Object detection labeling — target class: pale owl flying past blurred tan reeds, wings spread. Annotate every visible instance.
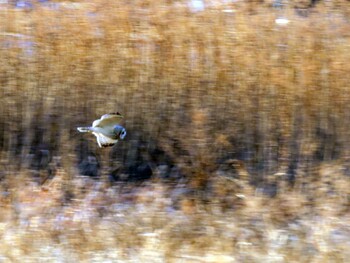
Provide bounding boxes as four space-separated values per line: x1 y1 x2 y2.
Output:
77 112 126 148
